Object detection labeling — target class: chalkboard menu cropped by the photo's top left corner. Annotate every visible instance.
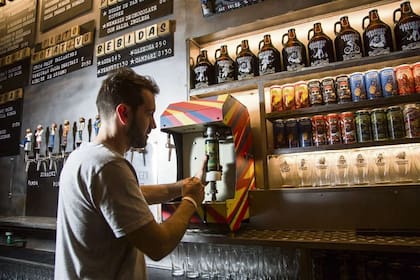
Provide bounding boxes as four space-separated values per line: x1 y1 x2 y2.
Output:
0 0 37 57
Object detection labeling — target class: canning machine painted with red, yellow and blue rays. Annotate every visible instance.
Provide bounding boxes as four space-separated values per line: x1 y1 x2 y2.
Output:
160 95 255 231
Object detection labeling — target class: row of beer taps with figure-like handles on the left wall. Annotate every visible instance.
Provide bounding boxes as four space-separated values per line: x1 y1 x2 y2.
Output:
21 115 101 172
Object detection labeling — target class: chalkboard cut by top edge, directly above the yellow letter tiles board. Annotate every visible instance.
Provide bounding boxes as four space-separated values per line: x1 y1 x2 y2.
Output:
40 0 93 32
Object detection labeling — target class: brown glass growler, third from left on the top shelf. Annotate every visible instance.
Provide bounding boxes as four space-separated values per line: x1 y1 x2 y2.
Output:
236 40 258 80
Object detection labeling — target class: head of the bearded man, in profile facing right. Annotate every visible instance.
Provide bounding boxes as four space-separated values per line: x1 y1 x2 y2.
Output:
96 68 159 148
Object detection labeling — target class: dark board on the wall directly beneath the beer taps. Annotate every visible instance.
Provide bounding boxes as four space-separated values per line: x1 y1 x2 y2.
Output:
26 159 63 217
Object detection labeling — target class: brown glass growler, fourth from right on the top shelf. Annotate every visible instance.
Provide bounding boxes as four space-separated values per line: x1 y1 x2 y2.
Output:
308 22 334 66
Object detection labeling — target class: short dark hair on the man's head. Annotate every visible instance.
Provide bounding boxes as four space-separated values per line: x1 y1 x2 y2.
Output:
96 67 159 118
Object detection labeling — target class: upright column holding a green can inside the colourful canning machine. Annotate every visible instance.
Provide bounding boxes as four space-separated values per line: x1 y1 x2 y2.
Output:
204 126 222 201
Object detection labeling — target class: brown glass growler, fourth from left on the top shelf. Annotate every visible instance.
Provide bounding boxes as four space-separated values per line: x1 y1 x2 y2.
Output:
258 34 281 76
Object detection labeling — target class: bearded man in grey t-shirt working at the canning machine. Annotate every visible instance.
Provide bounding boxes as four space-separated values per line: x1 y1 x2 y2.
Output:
55 68 205 280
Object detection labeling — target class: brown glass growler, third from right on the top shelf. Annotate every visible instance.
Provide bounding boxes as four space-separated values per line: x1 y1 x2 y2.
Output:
334 16 363 61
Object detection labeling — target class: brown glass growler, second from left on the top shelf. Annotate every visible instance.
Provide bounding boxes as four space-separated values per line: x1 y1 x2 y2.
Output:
214 45 236 84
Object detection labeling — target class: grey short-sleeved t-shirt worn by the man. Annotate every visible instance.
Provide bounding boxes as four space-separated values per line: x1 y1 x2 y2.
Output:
55 143 154 280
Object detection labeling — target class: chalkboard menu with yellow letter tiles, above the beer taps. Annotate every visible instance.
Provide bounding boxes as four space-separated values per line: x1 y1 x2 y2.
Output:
31 21 95 85
